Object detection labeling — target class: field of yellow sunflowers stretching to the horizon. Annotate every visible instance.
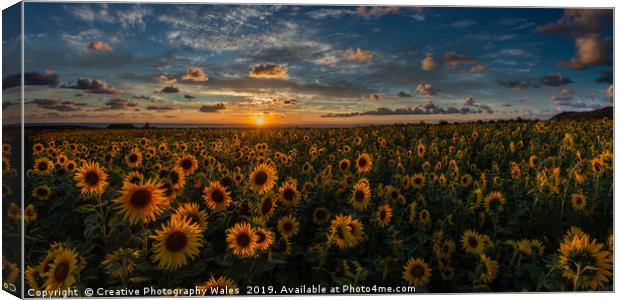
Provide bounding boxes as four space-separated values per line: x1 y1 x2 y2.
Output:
3 119 613 294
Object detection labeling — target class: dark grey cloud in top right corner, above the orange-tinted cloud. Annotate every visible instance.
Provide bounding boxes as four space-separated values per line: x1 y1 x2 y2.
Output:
536 9 613 37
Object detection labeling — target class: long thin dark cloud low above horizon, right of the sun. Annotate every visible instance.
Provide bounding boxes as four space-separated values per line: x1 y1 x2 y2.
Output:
321 103 492 118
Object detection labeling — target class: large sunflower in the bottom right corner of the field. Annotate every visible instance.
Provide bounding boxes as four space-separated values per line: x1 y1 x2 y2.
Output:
558 234 613 290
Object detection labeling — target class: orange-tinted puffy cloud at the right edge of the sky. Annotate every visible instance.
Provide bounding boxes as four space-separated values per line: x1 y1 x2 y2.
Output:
558 35 613 70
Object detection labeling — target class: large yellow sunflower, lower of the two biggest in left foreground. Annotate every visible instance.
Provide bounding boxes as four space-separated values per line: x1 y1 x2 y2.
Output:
151 216 202 271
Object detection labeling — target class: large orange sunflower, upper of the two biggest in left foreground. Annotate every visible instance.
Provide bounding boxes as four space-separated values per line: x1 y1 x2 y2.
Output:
112 179 168 225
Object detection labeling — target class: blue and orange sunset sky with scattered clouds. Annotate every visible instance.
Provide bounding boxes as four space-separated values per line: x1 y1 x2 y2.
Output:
3 3 613 126
